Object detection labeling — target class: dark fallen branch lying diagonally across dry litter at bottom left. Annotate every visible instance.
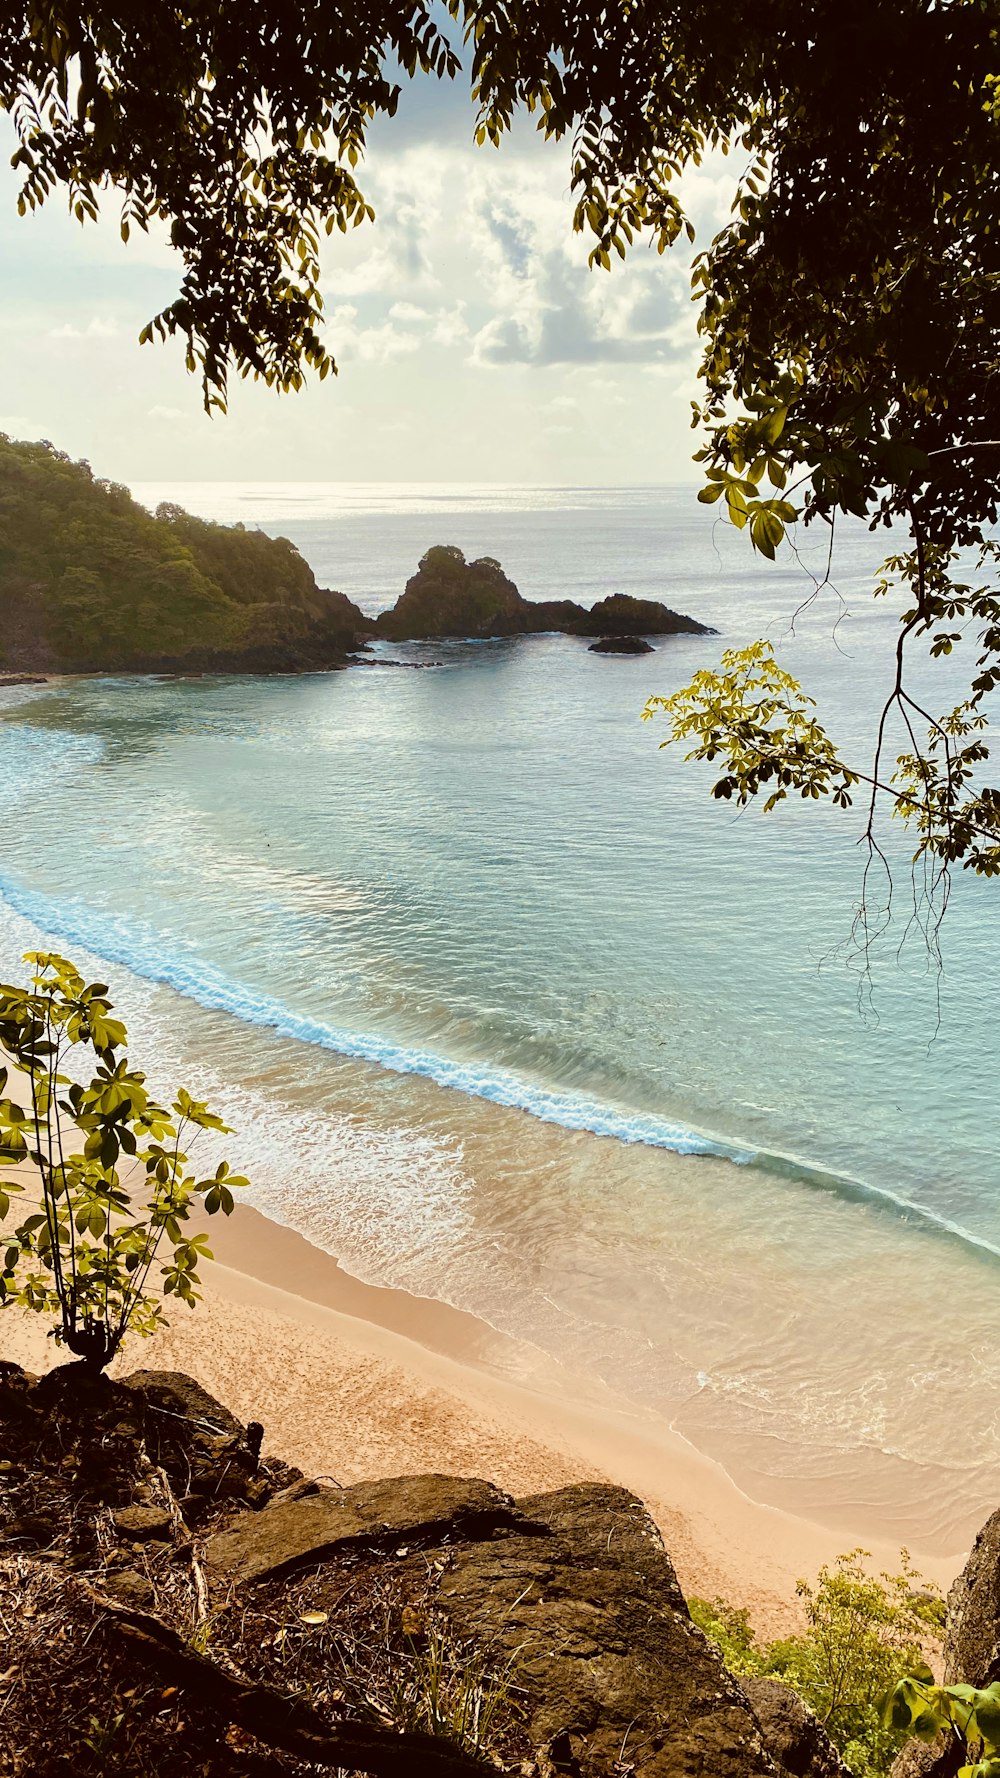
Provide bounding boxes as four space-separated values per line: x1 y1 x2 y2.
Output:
75 1581 496 1778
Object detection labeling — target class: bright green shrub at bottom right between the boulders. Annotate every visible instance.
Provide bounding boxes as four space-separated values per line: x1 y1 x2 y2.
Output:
689 1549 945 1778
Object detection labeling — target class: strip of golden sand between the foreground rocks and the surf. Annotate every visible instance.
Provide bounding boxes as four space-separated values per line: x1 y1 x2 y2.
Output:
0 1205 964 1634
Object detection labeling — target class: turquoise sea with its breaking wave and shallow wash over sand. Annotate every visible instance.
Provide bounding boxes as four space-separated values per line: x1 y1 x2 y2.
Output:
0 484 1000 1547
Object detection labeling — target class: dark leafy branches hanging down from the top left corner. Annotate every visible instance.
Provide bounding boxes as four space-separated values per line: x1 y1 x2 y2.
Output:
0 0 457 409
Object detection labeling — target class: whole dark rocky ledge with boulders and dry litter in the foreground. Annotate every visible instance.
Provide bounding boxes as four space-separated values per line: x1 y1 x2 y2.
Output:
0 1364 847 1778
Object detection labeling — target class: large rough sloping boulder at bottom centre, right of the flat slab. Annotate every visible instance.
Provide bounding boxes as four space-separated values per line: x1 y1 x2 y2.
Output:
436 1483 774 1778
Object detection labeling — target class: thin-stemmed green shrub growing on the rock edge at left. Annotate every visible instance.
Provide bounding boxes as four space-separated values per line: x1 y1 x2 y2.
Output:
0 951 247 1369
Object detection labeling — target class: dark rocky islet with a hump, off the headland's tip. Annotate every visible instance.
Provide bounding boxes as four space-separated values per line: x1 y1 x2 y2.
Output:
375 544 714 642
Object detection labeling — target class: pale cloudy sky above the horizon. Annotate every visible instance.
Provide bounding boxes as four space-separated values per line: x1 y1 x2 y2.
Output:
0 64 731 485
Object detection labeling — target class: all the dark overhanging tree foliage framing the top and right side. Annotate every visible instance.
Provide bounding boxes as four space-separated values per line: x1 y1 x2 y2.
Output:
0 0 1000 891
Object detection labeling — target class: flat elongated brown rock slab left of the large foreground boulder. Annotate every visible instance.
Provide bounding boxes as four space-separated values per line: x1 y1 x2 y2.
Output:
205 1476 528 1586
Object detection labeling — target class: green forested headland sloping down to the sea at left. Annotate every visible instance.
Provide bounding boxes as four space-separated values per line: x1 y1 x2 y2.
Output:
0 434 363 672
